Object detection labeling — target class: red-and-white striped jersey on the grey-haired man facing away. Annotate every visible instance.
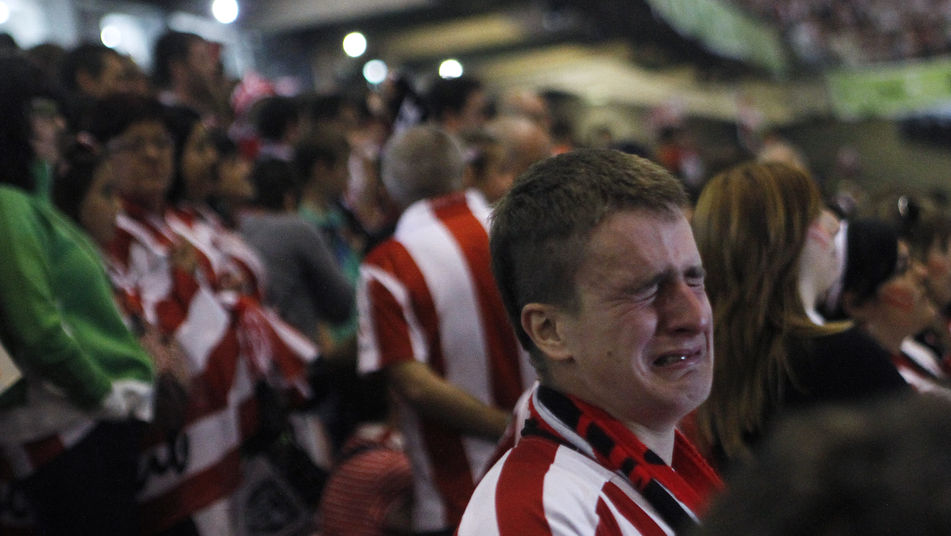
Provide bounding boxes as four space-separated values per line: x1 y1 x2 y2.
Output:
357 192 534 531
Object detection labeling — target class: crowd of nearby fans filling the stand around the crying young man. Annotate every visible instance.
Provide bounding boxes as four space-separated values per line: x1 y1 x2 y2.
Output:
0 18 951 536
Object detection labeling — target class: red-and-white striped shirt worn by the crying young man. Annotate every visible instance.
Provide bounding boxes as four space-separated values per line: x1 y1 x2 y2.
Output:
456 389 719 536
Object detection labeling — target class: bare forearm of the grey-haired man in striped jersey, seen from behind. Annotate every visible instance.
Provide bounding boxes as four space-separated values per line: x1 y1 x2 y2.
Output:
386 361 509 441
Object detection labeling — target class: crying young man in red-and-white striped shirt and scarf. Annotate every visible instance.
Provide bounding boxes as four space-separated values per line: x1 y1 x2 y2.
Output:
458 150 721 536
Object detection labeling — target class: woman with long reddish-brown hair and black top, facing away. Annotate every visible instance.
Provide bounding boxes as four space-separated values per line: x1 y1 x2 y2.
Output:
693 163 907 463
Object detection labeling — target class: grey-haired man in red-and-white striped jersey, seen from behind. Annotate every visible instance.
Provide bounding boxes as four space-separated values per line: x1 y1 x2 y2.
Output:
357 126 534 534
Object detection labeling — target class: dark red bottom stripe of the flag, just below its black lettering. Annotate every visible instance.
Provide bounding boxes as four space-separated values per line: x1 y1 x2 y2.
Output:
141 447 241 533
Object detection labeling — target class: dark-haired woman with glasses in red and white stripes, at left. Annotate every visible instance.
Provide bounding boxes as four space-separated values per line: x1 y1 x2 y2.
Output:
89 94 256 534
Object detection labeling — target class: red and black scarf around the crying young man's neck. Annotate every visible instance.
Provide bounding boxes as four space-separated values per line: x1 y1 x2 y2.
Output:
522 386 723 530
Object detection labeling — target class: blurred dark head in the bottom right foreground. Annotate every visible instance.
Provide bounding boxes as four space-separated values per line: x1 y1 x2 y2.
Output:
690 397 951 536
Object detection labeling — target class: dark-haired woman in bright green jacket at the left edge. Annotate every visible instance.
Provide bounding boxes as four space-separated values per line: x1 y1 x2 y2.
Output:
0 58 153 534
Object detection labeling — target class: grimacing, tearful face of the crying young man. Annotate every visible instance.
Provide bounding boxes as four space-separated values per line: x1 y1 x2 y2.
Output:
556 210 713 430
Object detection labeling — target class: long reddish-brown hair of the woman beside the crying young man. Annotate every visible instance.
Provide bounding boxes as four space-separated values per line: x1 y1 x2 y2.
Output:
693 162 842 459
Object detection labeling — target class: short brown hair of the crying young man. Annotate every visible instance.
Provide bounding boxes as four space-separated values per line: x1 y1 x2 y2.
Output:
490 149 687 372
